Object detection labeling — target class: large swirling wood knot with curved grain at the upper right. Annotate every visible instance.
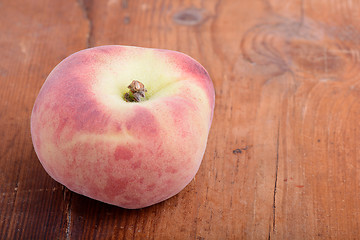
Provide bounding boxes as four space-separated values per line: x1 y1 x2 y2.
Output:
241 18 352 79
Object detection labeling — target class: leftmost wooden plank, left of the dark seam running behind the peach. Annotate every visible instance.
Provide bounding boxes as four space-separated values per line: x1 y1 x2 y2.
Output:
0 1 88 239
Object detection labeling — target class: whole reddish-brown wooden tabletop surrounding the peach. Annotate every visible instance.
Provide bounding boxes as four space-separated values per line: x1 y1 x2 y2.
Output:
0 0 360 240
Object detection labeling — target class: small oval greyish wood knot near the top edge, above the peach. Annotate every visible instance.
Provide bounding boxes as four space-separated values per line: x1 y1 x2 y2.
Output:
173 8 203 26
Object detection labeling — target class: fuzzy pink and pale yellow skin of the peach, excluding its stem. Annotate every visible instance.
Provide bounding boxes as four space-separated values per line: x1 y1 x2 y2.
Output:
31 45 215 209
